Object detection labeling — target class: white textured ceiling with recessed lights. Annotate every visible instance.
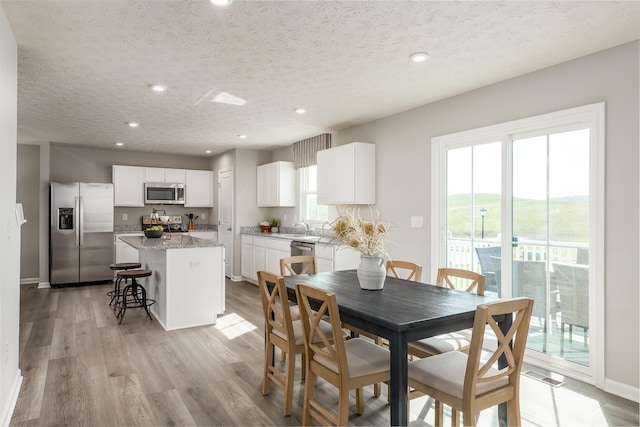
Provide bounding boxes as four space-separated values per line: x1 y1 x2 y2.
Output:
2 0 640 155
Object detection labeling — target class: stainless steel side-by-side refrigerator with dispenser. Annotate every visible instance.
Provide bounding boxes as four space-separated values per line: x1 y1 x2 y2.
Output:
49 182 113 286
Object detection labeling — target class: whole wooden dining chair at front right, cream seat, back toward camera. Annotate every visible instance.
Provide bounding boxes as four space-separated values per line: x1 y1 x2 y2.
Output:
409 298 533 426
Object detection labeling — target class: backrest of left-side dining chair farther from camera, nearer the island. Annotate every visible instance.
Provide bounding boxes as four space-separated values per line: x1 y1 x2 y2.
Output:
258 270 295 342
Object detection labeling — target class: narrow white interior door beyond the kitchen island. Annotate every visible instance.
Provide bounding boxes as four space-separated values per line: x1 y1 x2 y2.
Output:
218 169 234 277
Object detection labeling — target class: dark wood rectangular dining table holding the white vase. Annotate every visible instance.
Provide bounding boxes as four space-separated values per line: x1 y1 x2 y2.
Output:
284 270 511 426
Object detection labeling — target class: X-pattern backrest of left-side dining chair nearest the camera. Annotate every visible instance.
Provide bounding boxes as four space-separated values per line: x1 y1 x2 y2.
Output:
296 283 349 382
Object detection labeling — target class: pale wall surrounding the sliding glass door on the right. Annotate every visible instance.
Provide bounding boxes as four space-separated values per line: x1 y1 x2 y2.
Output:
332 42 640 399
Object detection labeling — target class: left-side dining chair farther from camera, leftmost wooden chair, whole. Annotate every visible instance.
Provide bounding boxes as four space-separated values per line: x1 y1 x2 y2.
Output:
258 271 331 416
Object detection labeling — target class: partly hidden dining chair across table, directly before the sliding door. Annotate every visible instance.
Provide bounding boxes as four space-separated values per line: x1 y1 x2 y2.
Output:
409 268 485 357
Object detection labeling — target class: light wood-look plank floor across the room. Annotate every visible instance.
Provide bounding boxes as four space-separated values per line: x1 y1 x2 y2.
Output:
11 280 638 427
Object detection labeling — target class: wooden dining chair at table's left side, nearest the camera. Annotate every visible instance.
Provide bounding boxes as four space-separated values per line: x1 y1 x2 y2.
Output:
296 283 391 426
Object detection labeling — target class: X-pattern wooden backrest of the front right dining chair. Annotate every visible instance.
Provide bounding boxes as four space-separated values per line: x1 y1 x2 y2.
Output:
463 298 533 402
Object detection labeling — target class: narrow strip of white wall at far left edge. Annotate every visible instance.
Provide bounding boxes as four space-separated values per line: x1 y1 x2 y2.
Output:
0 7 22 425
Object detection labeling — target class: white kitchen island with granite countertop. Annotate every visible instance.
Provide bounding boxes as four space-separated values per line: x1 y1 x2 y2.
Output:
120 233 225 331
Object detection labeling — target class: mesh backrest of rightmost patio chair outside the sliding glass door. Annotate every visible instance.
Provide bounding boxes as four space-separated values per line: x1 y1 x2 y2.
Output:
551 262 589 327
